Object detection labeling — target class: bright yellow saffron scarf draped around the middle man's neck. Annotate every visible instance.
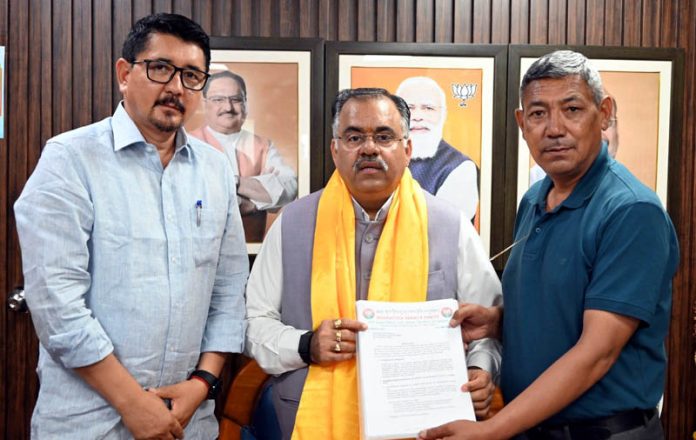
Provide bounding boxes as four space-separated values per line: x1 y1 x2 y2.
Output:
292 168 428 440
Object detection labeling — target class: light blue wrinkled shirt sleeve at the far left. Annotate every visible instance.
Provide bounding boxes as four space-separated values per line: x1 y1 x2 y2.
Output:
14 142 113 368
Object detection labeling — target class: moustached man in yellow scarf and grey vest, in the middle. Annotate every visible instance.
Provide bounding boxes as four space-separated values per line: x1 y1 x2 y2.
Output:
247 89 501 440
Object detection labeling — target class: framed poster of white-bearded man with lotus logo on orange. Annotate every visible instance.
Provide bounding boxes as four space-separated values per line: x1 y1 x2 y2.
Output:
325 42 507 260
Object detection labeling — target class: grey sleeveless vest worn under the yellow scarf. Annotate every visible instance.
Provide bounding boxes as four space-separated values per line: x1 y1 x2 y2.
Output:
273 191 460 439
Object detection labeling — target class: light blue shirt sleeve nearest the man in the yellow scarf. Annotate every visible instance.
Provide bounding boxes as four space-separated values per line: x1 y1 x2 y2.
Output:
201 163 249 353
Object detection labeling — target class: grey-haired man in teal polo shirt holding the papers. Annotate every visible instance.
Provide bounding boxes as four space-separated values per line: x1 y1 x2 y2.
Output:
421 51 679 440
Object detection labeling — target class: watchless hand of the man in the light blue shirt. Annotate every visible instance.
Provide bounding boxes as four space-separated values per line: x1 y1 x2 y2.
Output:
119 391 184 440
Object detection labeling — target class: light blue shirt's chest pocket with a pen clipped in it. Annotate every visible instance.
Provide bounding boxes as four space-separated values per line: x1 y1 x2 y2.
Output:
191 208 227 267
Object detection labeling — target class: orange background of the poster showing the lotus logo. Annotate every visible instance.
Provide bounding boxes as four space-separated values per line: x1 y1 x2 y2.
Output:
351 67 483 167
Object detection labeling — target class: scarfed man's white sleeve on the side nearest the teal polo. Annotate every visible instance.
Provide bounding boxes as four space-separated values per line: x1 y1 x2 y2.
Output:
457 216 503 383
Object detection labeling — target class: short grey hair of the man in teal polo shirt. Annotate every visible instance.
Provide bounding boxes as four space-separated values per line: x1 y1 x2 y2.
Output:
520 50 604 105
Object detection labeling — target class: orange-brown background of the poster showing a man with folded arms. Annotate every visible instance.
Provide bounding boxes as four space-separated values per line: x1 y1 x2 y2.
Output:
186 60 299 173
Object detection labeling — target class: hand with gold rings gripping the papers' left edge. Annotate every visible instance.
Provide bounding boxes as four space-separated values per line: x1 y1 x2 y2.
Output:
310 318 367 364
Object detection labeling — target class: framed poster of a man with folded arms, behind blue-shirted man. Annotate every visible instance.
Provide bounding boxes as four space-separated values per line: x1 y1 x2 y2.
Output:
186 37 323 254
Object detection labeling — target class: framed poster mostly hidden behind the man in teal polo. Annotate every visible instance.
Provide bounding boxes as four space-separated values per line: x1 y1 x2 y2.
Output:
506 45 683 254
